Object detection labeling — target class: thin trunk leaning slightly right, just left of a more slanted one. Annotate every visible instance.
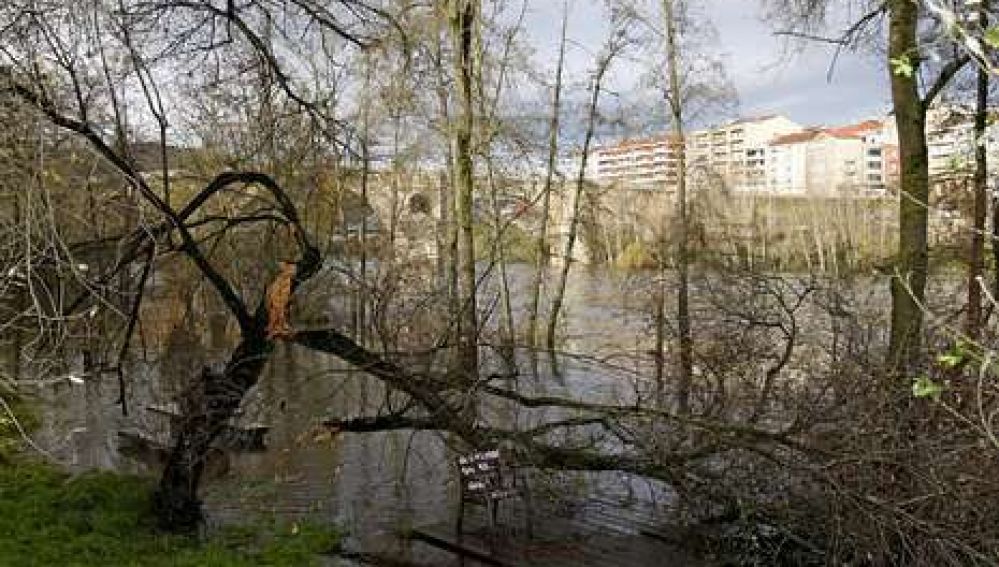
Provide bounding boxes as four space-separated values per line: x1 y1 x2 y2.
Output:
527 1 569 352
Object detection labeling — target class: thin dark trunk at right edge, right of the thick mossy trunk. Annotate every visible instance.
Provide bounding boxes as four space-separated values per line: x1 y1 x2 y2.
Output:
965 0 994 338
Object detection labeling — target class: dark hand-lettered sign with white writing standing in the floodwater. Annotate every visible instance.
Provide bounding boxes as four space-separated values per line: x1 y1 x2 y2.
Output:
457 449 531 534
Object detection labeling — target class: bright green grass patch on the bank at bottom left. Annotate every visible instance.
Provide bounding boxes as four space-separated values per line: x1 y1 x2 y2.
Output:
0 463 339 567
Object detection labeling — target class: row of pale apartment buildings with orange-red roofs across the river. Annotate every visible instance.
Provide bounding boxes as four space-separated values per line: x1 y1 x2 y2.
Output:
590 115 898 196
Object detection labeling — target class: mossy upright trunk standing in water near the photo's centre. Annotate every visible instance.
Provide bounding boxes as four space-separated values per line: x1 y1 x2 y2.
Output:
448 0 479 379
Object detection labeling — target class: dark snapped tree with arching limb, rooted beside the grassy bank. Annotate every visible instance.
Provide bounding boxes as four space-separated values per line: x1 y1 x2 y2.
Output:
0 1 387 529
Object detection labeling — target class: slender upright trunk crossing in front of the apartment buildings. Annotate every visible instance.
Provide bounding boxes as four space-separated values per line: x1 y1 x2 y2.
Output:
659 0 692 414
